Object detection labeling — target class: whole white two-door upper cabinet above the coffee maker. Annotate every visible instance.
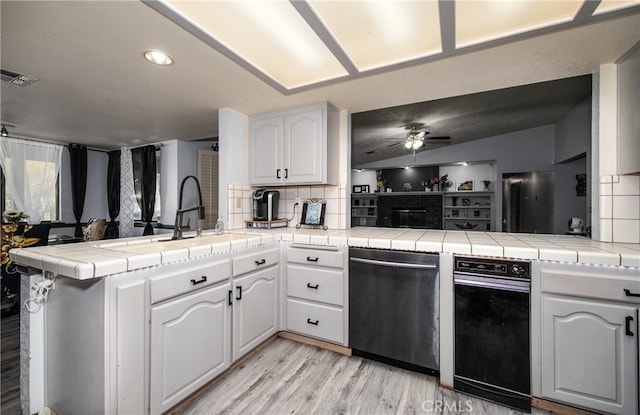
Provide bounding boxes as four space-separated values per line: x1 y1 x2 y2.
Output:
249 102 340 185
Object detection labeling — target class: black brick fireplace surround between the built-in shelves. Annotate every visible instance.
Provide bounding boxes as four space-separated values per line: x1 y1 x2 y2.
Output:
377 194 442 229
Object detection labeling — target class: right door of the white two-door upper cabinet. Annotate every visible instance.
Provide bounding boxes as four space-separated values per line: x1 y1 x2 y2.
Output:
283 108 326 184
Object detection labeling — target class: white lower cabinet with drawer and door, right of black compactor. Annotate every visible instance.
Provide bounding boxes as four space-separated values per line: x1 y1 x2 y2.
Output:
532 263 640 415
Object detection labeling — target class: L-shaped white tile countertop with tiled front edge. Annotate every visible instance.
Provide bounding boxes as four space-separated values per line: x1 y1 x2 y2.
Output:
9 227 640 279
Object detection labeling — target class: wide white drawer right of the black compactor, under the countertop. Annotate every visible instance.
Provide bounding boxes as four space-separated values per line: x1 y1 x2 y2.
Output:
540 265 640 304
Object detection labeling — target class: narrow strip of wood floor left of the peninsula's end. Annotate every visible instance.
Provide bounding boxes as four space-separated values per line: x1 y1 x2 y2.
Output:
0 314 20 415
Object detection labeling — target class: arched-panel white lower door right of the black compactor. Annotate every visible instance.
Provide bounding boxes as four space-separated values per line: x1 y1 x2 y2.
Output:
541 297 638 414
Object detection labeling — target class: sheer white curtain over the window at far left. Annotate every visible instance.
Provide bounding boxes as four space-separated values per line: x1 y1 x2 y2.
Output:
0 137 64 223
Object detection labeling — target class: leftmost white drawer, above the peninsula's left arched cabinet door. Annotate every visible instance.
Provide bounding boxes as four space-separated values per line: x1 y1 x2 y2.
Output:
149 259 231 304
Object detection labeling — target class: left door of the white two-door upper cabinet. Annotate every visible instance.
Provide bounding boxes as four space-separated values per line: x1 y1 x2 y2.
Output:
249 115 285 185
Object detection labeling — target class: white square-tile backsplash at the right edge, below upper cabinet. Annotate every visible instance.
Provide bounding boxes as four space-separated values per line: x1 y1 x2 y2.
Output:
600 175 640 243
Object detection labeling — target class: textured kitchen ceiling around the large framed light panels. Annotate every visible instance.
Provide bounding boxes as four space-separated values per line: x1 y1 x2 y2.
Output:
0 0 640 162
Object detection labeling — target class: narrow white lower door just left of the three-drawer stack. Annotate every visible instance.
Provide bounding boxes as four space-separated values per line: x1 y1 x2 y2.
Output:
233 266 280 361
